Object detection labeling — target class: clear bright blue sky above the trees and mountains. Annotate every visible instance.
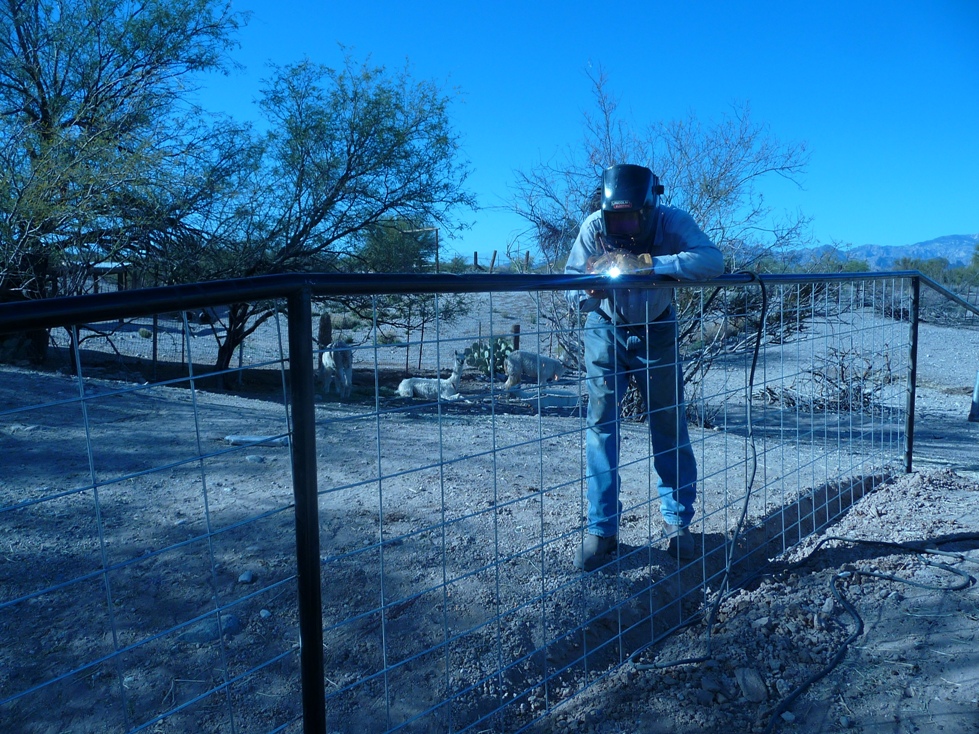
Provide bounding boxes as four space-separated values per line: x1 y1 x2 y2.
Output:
204 0 979 258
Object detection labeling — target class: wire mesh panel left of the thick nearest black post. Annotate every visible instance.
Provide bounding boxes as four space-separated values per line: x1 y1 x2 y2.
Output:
0 300 301 732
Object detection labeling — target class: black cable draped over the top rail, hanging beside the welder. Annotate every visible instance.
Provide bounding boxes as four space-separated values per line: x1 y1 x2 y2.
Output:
629 271 768 670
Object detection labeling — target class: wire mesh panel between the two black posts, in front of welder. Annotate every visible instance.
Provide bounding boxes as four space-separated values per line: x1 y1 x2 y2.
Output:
304 281 909 731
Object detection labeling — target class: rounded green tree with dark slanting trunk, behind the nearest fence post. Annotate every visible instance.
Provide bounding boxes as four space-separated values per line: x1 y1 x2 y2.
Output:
195 55 475 380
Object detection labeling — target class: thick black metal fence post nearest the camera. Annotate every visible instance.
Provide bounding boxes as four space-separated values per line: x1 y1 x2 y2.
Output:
287 287 326 734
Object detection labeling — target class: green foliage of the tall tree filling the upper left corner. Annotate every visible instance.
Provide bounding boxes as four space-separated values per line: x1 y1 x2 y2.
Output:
0 0 240 297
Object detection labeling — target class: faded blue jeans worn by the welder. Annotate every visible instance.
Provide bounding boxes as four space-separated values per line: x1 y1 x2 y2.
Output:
583 308 697 536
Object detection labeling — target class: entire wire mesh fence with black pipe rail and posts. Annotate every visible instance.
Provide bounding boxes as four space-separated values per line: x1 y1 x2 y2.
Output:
0 273 931 732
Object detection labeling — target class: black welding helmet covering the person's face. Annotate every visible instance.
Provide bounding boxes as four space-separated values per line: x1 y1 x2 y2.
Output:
602 163 663 249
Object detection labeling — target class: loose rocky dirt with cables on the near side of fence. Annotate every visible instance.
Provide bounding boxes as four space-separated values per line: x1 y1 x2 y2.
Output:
552 469 979 734
